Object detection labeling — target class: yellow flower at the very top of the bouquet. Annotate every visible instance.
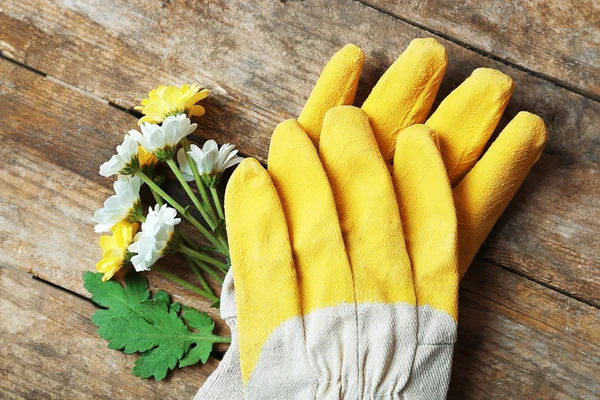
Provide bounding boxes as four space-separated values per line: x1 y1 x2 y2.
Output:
135 83 208 125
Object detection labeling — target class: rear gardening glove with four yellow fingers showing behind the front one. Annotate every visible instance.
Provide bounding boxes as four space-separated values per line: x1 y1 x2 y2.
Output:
198 39 547 398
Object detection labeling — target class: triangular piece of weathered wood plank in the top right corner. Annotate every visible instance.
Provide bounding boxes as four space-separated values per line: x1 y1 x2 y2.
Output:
359 0 600 99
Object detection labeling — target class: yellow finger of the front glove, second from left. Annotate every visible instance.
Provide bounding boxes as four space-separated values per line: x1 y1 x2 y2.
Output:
268 119 354 315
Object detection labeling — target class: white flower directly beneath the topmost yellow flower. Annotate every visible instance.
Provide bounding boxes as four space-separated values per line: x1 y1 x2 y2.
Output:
129 114 198 161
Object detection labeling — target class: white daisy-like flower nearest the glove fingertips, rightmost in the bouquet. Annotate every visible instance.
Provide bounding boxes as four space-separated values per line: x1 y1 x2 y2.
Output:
177 140 243 186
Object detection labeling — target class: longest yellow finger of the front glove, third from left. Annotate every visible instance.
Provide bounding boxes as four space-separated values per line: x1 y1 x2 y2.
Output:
319 106 415 304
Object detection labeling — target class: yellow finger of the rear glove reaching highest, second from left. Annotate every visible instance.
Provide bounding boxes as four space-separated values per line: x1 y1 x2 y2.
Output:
362 39 448 162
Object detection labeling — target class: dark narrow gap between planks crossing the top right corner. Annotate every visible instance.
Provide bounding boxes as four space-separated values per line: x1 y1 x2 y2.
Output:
354 0 600 102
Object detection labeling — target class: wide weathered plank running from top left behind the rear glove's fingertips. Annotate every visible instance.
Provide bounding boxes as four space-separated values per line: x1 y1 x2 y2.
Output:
0 0 600 305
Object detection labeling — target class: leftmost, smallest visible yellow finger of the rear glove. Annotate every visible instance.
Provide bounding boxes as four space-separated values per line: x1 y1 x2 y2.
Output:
298 44 364 147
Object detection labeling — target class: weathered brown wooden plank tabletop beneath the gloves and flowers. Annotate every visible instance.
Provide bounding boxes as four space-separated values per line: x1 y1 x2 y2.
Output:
0 0 600 399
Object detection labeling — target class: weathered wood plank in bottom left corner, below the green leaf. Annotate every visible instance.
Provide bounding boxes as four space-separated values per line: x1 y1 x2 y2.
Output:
0 268 218 400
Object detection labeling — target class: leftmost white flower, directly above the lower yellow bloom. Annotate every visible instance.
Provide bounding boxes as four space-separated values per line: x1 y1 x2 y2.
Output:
92 176 142 232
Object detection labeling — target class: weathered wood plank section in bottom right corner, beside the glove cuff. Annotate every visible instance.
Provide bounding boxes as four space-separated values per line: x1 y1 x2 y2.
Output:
449 262 600 400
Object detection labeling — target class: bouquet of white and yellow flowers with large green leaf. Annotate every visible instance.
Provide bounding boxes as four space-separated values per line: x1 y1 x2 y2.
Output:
83 85 242 380
